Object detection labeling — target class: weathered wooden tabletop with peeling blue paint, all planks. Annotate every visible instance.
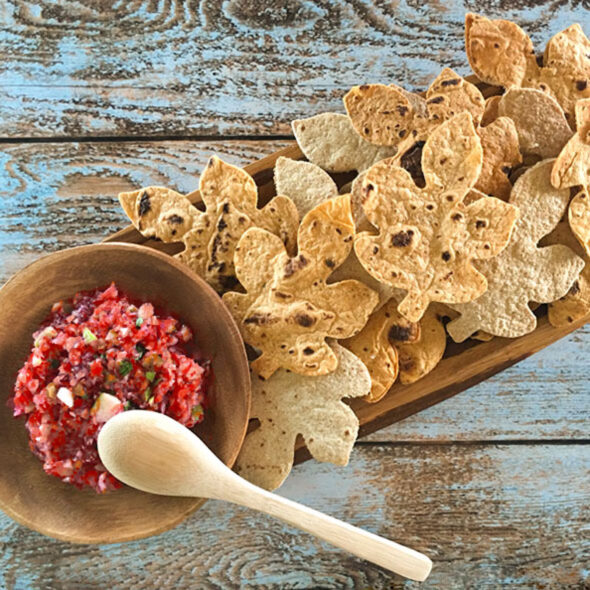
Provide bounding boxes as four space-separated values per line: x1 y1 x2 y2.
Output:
0 0 590 590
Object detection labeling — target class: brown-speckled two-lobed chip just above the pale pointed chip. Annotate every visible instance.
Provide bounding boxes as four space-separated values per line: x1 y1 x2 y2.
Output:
344 68 485 149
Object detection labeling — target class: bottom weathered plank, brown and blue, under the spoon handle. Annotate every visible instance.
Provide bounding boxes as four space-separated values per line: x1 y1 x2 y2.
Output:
0 445 590 590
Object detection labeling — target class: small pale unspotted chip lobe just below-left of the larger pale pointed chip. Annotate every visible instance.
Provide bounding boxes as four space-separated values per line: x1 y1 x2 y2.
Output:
274 157 338 218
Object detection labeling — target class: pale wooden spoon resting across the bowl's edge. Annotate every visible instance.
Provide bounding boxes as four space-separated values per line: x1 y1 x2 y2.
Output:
98 410 432 581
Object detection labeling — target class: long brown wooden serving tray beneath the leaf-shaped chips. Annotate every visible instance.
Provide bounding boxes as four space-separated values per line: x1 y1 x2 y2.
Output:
105 142 590 448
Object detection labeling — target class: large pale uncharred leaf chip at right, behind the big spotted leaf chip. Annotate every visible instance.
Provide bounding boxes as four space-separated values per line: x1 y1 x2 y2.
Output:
447 160 584 342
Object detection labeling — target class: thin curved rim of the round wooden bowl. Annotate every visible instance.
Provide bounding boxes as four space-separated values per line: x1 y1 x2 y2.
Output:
0 242 252 545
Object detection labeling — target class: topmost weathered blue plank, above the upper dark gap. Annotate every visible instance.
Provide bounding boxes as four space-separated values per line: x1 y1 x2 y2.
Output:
0 0 588 137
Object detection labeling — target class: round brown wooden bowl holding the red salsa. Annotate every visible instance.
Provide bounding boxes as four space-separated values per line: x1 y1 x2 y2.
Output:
0 243 250 543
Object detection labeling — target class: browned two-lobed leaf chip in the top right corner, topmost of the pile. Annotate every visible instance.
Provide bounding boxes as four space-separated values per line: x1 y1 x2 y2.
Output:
465 13 590 121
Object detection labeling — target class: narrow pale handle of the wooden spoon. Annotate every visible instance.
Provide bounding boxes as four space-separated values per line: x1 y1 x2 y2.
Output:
221 474 432 582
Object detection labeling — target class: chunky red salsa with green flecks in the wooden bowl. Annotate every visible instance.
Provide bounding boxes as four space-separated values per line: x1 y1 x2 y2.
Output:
11 284 211 492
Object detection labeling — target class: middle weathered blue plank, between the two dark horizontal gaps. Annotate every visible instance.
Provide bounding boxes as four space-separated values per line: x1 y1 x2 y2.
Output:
0 141 590 441
